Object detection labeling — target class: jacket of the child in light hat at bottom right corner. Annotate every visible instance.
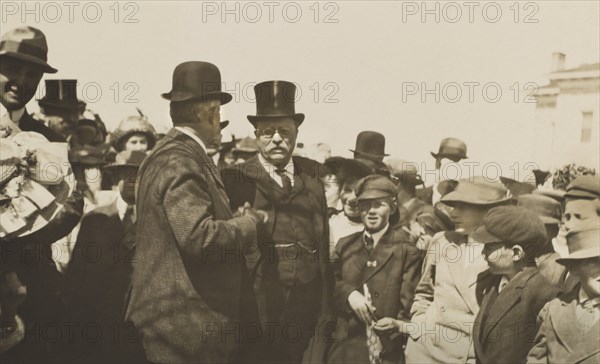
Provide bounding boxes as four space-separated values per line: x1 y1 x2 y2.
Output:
527 285 600 364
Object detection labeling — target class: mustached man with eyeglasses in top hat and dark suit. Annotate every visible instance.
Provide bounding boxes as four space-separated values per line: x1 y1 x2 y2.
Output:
222 81 329 363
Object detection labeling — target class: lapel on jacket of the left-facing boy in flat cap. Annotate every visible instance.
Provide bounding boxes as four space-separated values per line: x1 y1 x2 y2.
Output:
483 268 537 339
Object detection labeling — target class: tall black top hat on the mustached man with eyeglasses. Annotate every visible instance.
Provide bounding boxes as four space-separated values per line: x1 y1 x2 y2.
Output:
248 81 304 126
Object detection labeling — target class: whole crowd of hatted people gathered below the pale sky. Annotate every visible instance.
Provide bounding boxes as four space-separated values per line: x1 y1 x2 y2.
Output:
0 26 600 364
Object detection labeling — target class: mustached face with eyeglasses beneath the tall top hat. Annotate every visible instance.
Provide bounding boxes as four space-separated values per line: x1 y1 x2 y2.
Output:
255 117 298 166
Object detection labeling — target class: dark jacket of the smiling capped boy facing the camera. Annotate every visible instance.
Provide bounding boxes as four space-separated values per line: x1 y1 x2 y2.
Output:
328 227 422 363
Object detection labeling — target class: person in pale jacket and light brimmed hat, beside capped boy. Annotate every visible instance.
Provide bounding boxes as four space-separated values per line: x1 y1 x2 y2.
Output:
406 177 512 363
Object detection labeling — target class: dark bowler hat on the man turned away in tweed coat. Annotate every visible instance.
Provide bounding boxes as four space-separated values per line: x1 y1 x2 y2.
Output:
162 61 232 105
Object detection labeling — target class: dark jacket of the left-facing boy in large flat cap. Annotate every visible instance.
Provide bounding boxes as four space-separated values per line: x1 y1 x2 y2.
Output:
473 267 558 364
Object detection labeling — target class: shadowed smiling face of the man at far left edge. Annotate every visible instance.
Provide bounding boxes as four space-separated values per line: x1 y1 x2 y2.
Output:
0 57 44 111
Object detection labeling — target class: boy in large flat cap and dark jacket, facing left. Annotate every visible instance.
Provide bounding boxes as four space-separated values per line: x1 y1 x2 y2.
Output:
473 206 558 364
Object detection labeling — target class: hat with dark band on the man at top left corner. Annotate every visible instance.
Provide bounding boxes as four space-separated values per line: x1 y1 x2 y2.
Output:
0 26 56 73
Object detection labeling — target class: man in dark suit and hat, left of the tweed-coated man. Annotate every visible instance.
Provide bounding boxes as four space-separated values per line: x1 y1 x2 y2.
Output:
64 151 146 363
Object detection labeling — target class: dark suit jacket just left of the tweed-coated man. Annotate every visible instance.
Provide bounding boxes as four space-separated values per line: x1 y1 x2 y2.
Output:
63 201 137 362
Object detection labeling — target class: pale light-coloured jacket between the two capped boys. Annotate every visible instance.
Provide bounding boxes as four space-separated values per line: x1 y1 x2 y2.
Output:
405 232 492 363
